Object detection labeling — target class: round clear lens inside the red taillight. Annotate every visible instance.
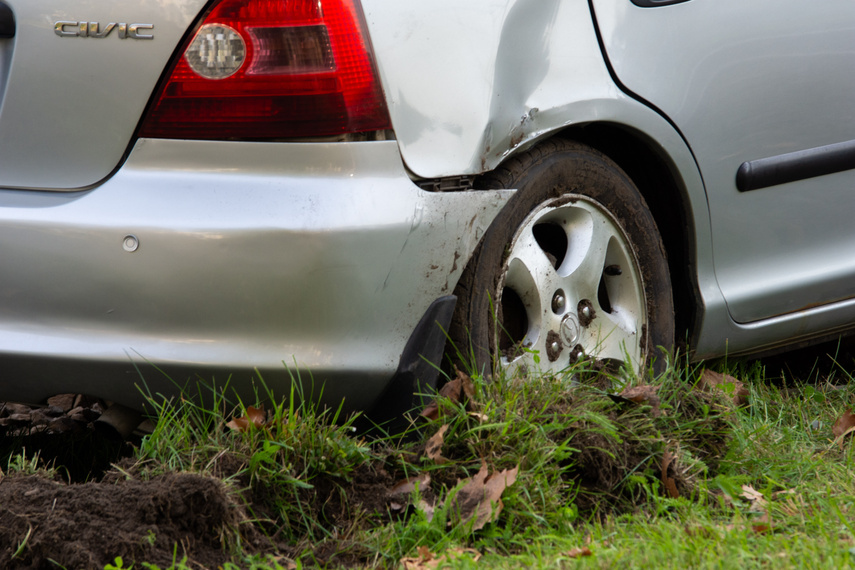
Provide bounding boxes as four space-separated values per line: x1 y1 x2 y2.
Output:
184 24 246 79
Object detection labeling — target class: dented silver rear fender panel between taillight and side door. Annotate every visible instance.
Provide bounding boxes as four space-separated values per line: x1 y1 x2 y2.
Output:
363 0 623 178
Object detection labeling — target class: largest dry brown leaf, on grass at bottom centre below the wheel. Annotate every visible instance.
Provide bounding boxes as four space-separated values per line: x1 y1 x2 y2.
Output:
453 462 519 530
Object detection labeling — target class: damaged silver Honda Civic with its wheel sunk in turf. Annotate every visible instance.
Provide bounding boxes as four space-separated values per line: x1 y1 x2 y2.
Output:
0 0 855 409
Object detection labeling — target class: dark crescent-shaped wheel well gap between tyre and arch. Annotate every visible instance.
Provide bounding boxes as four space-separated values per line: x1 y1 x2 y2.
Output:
560 123 700 351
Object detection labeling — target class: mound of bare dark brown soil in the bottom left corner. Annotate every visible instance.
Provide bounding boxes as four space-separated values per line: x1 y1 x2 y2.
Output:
0 468 243 569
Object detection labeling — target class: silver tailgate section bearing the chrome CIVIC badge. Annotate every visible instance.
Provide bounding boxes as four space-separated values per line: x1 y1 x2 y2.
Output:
0 0 205 190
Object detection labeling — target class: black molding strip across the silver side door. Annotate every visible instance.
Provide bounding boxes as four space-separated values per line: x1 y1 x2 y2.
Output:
736 141 855 192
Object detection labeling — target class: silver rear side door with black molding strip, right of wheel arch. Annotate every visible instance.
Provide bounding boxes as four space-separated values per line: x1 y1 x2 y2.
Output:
591 0 855 323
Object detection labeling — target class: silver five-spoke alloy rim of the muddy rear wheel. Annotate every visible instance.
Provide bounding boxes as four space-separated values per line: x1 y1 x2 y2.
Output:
496 195 647 373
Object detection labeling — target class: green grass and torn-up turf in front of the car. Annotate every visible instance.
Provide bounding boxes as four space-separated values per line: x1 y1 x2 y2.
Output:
8 344 855 569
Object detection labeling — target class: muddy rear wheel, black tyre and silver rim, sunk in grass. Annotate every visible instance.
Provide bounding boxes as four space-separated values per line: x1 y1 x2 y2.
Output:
451 139 674 373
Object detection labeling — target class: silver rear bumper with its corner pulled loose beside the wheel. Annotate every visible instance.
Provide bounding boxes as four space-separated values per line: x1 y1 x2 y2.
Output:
0 140 511 408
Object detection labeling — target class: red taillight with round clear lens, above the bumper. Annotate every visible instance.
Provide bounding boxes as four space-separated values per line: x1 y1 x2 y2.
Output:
139 0 391 140
